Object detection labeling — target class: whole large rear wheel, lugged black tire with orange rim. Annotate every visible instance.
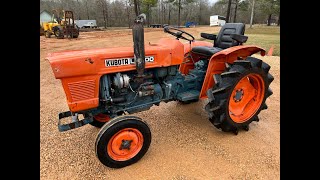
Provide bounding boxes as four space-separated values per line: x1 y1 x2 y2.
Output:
205 57 274 134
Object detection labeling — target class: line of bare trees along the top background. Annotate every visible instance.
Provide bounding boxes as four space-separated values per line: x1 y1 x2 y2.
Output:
40 0 280 28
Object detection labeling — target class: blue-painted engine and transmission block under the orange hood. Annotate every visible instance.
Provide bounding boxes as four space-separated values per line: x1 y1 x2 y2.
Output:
99 60 208 116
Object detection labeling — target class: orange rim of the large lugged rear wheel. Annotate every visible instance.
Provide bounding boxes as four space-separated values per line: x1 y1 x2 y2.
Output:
229 74 265 123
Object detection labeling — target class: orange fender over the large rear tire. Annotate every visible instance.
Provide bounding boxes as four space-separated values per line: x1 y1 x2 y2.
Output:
200 45 266 99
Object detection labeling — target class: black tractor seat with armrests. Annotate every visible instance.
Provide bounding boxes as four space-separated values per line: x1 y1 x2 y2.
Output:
191 23 245 57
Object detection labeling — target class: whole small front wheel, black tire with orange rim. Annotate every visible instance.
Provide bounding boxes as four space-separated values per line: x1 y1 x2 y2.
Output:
95 116 151 168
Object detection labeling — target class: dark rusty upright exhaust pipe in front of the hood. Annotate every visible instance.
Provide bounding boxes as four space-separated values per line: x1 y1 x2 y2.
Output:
132 14 146 82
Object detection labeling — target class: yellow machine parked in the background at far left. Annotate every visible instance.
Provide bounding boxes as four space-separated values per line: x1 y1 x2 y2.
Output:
42 10 79 39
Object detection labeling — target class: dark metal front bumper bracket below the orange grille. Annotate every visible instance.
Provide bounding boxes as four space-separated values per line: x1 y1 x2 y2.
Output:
58 111 93 132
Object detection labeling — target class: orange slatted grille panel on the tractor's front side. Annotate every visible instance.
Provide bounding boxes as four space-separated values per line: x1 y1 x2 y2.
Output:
68 80 95 101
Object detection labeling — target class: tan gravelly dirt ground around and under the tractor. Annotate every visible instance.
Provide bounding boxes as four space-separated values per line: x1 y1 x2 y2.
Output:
40 27 280 180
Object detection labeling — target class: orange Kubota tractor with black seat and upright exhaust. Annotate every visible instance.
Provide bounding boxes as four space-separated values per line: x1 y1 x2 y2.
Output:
47 15 273 168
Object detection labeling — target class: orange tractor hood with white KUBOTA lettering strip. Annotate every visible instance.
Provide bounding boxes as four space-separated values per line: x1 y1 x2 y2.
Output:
46 38 184 79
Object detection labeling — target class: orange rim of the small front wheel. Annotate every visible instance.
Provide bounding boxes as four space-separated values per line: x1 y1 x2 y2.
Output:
107 128 143 161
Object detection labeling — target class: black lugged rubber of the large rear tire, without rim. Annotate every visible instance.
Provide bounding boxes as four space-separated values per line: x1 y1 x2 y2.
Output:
205 57 274 135
